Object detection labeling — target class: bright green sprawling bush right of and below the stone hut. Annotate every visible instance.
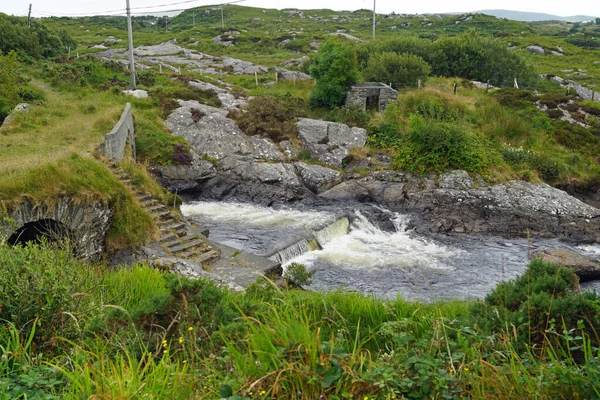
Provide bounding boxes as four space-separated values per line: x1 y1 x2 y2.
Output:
395 115 490 173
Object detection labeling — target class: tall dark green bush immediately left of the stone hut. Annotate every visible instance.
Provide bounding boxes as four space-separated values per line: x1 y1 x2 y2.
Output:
309 40 359 108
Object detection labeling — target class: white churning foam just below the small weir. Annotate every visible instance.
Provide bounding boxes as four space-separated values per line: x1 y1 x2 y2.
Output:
294 212 460 269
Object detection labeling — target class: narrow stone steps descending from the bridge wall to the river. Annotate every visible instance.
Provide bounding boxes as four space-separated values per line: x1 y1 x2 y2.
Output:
108 164 221 265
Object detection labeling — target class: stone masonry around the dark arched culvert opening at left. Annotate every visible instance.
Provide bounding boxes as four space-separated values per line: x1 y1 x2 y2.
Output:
0 196 113 259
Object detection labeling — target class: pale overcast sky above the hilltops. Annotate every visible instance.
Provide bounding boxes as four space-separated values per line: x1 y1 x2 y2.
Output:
0 0 600 17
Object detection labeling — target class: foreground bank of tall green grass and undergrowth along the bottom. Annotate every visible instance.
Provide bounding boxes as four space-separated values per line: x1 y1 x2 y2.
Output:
0 242 600 399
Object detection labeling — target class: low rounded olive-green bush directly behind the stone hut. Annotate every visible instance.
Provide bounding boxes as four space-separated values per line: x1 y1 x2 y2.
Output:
363 52 431 87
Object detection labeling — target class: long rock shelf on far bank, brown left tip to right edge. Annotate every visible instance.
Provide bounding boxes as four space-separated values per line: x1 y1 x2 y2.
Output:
320 171 600 242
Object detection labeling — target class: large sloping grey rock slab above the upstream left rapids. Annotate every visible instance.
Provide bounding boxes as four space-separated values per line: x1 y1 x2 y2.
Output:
160 101 311 204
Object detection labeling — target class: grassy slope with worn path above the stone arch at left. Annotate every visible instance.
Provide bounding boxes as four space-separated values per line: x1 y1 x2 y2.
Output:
0 57 203 251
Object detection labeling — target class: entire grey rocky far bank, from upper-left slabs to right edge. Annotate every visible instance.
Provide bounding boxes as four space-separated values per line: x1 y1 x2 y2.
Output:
157 93 600 243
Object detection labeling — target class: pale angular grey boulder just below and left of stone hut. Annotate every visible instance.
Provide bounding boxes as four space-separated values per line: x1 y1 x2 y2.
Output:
298 118 367 167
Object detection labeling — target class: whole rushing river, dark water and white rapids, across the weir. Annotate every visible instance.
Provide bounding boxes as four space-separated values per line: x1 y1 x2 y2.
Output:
181 202 600 301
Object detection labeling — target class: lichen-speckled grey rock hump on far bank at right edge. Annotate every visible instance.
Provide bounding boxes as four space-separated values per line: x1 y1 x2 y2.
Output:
405 181 600 242
